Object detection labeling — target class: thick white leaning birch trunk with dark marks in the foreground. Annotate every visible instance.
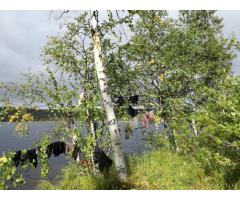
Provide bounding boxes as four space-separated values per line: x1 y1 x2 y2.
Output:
91 15 127 181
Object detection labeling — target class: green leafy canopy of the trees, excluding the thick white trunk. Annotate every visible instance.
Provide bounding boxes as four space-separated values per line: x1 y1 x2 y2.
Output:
0 10 240 188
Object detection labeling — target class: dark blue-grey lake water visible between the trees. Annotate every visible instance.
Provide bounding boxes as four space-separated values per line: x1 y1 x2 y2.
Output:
0 121 161 189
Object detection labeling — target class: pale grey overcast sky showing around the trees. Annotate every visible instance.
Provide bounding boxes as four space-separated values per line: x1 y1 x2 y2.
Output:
0 11 240 81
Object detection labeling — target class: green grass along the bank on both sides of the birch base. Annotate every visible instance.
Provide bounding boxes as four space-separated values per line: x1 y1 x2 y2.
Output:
40 149 227 190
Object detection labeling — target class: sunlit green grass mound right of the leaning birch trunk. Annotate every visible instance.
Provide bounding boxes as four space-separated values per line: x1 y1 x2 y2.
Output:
128 149 222 190
